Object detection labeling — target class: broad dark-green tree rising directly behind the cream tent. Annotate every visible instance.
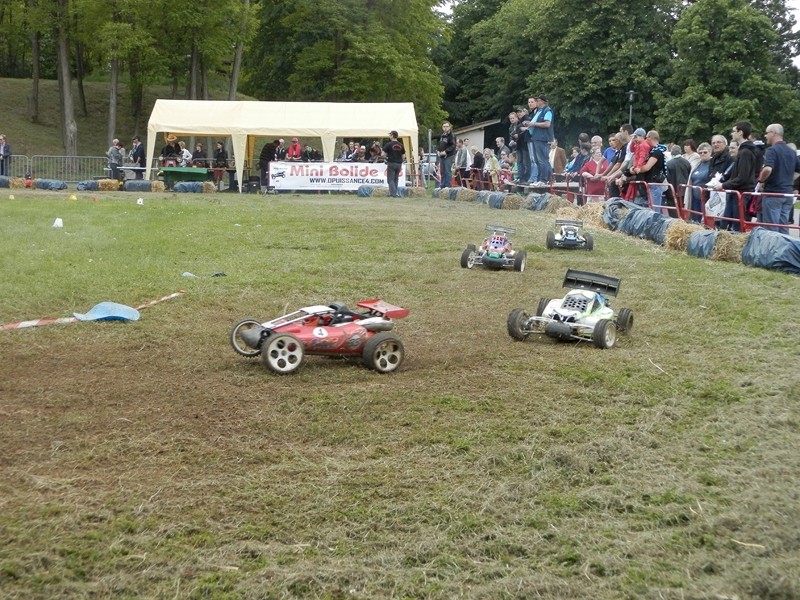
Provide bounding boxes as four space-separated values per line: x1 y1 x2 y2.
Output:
242 0 443 132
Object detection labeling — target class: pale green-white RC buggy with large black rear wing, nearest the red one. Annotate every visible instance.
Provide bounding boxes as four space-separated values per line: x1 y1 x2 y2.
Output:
507 269 633 348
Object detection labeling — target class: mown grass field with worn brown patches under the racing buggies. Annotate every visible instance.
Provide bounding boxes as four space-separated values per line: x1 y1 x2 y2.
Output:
0 190 800 600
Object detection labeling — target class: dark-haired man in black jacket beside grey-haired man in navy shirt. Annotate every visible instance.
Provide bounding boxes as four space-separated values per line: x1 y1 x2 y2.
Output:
712 121 760 231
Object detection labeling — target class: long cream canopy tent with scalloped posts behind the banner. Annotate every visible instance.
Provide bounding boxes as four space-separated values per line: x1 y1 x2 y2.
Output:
145 100 418 189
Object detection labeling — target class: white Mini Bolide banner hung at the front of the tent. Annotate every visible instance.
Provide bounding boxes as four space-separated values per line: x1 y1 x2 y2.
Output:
269 162 406 192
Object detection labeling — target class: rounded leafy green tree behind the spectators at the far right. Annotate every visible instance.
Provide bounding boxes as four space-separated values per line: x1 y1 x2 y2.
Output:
657 0 800 140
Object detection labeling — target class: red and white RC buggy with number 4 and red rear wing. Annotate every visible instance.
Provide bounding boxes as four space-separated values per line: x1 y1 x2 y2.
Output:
230 300 409 374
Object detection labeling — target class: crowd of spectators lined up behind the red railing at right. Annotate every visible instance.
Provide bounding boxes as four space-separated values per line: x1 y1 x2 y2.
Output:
436 95 800 233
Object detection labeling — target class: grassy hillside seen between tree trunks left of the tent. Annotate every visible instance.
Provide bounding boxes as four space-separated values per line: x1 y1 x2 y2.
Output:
0 78 253 156
